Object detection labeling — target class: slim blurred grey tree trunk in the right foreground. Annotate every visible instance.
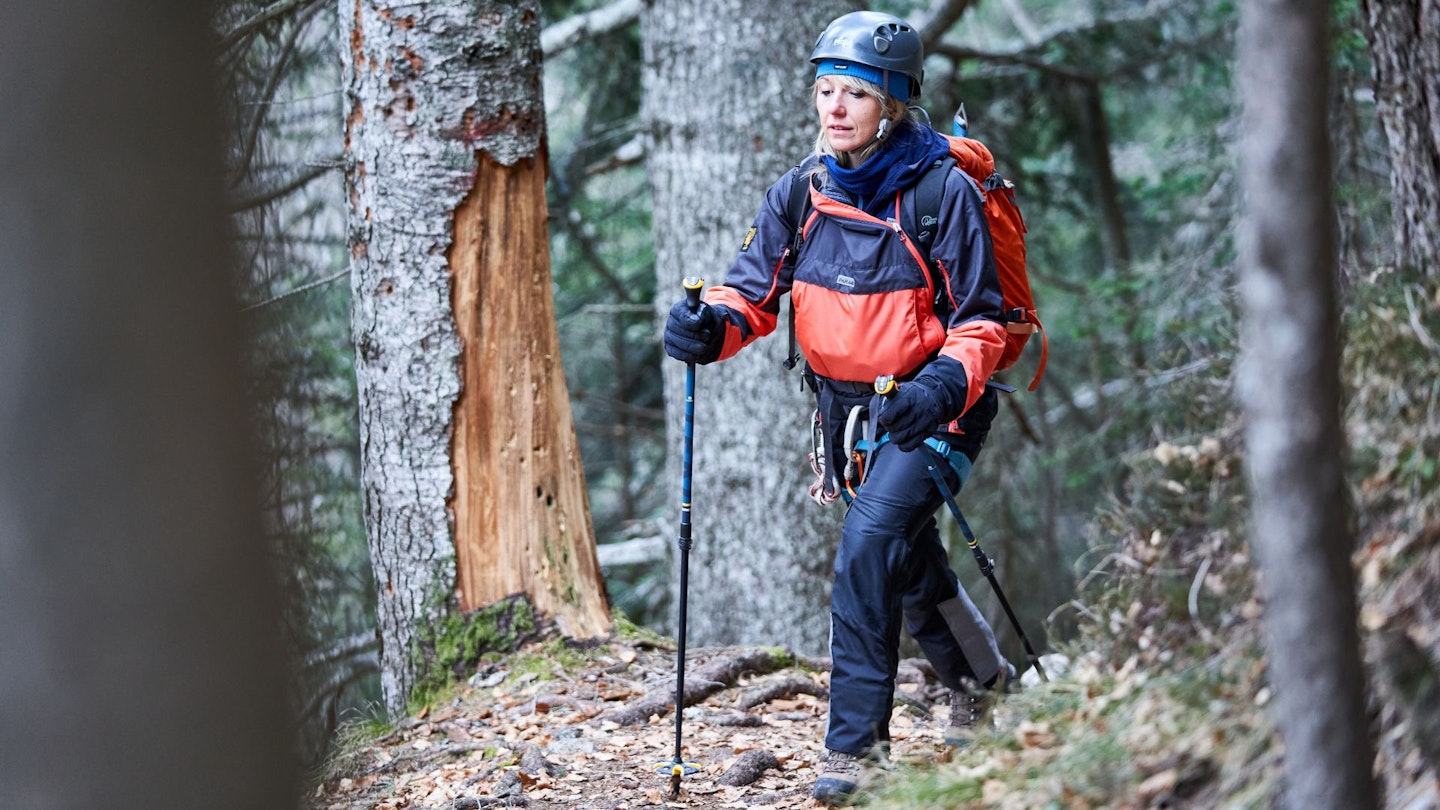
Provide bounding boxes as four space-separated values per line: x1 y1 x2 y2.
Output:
1240 0 1377 810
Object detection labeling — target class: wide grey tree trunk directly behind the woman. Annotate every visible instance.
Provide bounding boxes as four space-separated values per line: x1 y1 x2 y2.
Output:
641 0 854 651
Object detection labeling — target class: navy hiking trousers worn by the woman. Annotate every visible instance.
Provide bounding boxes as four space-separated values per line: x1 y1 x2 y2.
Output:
825 434 1012 755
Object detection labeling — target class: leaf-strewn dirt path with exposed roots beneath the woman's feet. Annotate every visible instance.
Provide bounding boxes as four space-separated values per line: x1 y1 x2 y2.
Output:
307 637 984 810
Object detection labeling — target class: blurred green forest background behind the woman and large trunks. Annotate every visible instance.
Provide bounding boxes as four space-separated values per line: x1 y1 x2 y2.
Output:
215 0 1440 795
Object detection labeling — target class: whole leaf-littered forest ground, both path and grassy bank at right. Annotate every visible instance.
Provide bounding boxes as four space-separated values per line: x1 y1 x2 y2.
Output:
305 484 1440 810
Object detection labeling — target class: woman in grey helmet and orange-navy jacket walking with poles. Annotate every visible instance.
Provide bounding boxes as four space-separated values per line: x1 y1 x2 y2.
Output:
665 12 1014 804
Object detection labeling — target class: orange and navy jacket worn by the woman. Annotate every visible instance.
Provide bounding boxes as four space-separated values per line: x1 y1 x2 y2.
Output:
706 161 1005 411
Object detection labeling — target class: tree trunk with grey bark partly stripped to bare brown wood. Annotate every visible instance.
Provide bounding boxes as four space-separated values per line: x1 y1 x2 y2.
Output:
341 0 609 712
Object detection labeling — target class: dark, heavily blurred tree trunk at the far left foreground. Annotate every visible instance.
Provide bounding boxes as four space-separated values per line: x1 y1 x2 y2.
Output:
0 0 295 809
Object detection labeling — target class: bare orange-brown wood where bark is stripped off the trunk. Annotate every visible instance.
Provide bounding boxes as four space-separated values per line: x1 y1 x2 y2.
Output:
449 148 609 619
